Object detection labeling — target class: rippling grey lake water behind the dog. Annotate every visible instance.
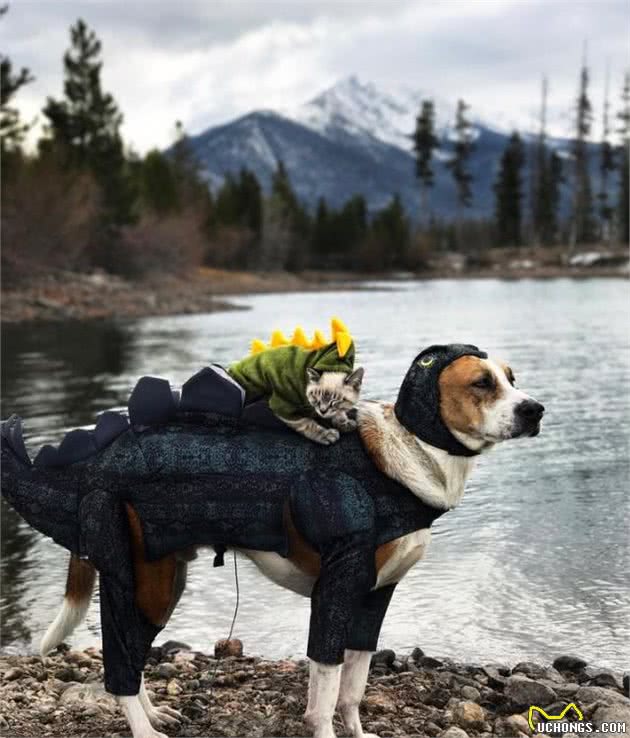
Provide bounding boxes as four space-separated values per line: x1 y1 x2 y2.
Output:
2 280 630 669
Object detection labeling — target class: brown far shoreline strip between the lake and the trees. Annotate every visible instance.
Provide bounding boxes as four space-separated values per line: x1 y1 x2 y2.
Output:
0 252 629 324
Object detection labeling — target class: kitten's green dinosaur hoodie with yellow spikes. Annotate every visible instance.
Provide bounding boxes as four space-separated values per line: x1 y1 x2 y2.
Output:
227 343 354 420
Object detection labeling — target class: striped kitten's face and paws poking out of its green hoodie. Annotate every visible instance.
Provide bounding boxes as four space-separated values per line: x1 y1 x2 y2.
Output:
278 367 363 446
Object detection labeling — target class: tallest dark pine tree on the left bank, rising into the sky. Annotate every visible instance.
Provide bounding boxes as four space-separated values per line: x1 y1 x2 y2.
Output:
43 19 135 225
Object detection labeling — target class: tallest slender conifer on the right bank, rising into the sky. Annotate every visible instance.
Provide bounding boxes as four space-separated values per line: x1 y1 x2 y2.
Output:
570 54 595 250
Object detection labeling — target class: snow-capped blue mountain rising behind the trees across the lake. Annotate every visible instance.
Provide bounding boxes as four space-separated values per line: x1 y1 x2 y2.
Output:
191 77 584 218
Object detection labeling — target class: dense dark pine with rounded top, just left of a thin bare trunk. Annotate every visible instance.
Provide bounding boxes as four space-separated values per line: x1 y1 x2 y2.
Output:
494 131 525 246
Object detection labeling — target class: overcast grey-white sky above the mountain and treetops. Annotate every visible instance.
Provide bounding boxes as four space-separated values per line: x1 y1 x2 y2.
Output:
2 0 629 152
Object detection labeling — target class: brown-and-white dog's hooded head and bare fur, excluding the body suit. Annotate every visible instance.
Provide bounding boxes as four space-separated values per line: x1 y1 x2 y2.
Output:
2 345 544 738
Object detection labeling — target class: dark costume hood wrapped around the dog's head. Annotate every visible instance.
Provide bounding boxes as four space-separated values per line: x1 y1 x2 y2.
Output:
394 343 488 456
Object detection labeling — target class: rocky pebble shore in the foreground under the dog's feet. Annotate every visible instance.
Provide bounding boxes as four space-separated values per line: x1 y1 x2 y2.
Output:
0 641 630 738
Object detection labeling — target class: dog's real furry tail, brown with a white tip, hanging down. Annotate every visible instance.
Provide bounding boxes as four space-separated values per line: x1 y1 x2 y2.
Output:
39 554 96 656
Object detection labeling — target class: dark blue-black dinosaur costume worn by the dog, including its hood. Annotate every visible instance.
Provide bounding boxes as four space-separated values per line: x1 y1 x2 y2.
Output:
1 344 486 695
